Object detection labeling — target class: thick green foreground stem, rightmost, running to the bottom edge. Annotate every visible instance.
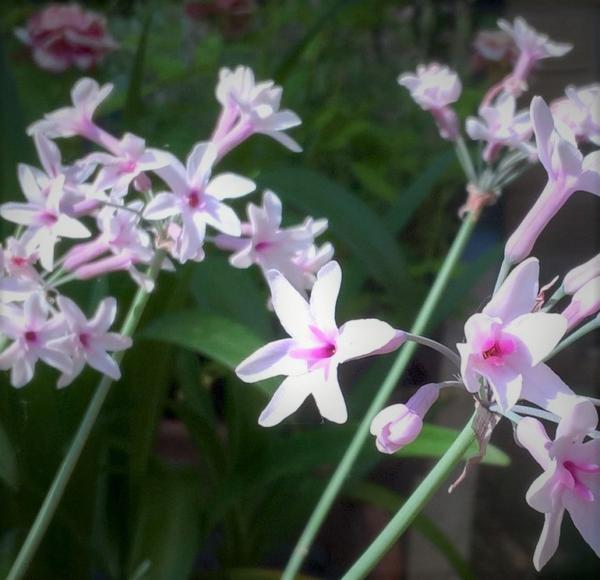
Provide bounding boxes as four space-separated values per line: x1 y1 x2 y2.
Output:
343 415 475 580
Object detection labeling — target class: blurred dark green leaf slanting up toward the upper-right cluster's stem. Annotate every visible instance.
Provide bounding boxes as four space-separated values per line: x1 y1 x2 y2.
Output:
385 151 454 234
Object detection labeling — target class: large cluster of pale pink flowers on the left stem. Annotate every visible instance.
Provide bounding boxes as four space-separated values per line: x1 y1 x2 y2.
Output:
0 66 326 387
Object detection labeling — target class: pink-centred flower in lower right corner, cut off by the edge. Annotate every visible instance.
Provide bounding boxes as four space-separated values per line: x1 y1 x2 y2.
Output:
516 400 600 570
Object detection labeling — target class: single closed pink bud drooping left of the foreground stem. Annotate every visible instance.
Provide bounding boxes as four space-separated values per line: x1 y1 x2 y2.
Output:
371 384 440 453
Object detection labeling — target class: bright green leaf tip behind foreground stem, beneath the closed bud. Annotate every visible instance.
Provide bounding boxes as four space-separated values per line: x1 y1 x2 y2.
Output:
394 423 510 467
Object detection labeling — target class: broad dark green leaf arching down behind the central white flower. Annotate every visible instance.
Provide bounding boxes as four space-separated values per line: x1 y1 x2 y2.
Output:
258 167 414 296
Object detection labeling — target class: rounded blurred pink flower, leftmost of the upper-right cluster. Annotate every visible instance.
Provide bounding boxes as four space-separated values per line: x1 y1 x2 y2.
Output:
398 63 462 140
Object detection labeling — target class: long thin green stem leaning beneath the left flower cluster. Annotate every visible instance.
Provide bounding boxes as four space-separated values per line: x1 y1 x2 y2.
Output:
6 251 165 580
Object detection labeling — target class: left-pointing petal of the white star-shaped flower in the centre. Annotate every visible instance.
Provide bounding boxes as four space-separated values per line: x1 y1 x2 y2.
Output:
235 338 308 383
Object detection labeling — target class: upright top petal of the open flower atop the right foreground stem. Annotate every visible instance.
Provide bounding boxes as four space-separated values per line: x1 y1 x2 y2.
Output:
482 258 540 324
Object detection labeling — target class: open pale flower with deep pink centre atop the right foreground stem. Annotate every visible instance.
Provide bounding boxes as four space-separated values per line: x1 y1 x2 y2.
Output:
457 258 573 415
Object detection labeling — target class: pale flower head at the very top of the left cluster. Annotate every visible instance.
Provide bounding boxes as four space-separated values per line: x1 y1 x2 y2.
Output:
212 66 302 157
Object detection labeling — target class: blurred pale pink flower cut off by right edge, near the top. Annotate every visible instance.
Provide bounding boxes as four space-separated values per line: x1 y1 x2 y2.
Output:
550 83 600 145
